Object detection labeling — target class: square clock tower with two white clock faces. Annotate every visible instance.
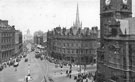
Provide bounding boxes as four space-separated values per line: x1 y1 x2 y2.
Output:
100 0 132 39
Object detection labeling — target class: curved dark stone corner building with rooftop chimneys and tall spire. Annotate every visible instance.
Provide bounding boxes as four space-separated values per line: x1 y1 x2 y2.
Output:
47 6 99 65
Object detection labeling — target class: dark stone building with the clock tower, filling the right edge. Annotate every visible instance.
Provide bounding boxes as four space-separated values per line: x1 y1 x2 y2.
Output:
96 0 135 82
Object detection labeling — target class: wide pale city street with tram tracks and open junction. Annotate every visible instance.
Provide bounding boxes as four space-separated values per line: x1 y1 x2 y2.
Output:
0 52 95 82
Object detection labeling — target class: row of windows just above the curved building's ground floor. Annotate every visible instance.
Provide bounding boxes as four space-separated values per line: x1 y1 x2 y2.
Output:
54 48 96 54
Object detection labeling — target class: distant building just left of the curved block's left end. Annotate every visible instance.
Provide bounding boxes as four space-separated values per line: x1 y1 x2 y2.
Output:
34 31 44 45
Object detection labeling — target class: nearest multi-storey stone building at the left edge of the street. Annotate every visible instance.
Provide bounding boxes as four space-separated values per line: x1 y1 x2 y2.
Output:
0 20 15 63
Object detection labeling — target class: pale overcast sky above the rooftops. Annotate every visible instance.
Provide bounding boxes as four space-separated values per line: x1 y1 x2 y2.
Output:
0 0 135 34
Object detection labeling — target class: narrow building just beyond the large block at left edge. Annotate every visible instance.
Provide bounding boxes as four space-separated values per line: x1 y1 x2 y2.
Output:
15 30 23 56
